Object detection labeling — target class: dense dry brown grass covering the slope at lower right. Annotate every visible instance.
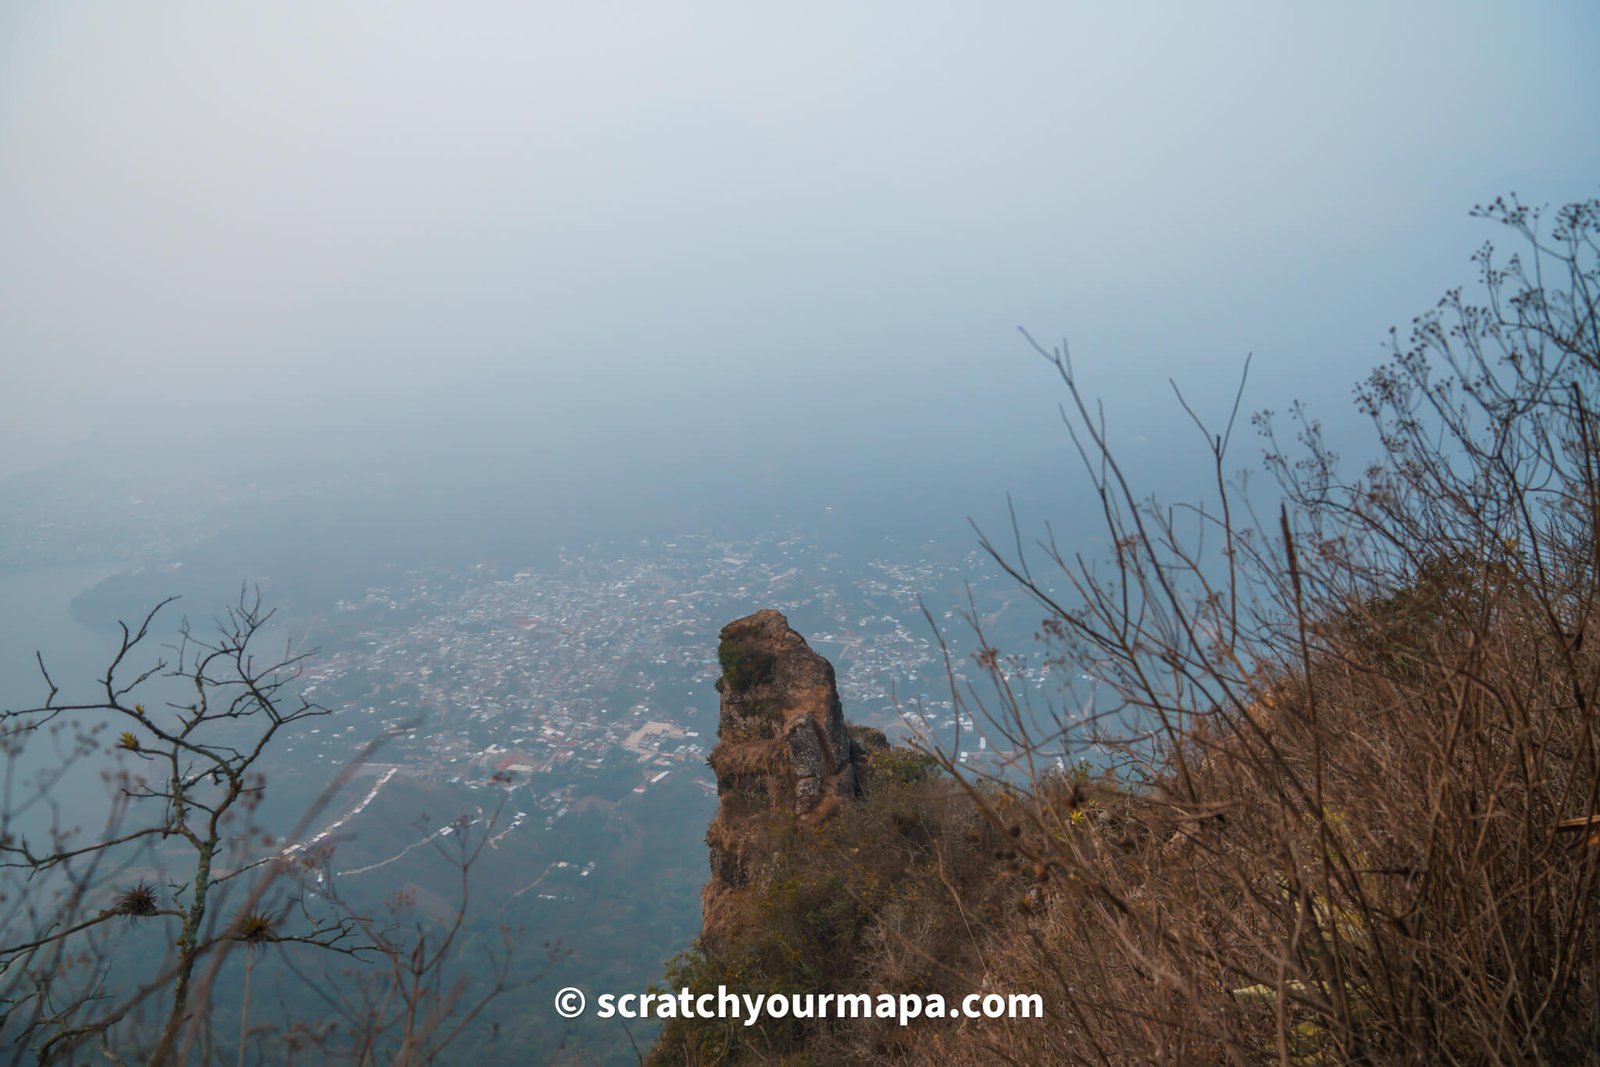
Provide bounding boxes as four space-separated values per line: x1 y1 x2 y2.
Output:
934 579 1600 1064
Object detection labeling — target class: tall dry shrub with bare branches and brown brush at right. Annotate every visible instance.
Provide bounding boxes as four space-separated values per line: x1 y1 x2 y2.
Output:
941 198 1600 1064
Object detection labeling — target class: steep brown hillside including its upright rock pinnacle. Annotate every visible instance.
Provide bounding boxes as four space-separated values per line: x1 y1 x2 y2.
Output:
653 576 1600 1064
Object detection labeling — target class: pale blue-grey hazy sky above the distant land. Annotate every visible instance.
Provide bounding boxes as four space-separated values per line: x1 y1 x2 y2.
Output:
0 0 1600 502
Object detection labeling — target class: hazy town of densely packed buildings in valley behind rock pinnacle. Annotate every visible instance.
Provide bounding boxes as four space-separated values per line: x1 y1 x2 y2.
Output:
281 536 992 851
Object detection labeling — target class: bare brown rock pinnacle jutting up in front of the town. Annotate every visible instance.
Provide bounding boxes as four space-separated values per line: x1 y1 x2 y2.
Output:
701 609 886 950
